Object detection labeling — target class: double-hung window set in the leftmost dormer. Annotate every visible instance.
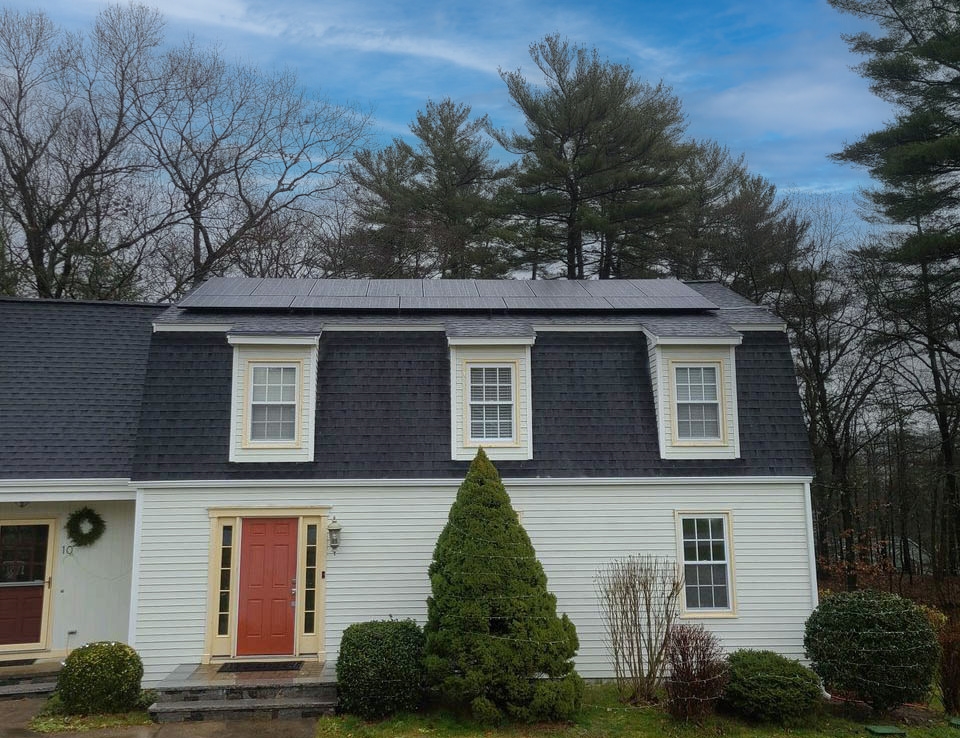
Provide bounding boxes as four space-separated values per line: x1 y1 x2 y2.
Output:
249 363 299 443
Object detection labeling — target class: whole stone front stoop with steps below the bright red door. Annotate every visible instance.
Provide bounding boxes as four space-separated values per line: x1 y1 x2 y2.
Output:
149 665 337 723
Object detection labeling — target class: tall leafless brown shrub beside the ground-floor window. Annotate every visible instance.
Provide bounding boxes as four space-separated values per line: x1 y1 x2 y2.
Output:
596 555 683 704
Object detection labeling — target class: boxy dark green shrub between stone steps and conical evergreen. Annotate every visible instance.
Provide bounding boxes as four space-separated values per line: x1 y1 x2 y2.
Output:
337 620 423 718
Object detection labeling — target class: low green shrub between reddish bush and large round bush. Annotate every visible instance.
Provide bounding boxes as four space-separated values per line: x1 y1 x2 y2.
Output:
723 651 821 724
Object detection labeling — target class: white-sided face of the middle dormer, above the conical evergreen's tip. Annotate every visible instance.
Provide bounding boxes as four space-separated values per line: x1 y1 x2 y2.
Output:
450 345 533 461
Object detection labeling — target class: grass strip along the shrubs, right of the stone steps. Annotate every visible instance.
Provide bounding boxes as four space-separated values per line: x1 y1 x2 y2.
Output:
317 686 960 738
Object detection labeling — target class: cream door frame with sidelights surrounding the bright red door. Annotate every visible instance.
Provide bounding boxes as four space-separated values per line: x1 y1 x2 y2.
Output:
201 506 330 663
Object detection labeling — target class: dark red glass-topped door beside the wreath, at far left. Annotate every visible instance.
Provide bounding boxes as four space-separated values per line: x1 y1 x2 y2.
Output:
0 522 50 650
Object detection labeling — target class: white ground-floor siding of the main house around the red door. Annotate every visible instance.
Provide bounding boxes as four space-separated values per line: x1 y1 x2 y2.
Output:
136 479 814 682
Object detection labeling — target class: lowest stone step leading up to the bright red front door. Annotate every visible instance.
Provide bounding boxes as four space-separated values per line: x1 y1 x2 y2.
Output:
148 697 336 723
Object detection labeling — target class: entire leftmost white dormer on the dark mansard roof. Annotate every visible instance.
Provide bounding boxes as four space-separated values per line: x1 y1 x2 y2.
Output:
227 335 319 462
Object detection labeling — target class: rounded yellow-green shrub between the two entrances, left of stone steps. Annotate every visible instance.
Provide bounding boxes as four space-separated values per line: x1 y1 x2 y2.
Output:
57 642 143 715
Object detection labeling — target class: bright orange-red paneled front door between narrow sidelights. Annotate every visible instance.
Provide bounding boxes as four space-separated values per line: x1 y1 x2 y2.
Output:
237 518 297 656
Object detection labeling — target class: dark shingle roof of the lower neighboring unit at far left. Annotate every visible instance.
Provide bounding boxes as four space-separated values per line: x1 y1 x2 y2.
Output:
0 299 162 479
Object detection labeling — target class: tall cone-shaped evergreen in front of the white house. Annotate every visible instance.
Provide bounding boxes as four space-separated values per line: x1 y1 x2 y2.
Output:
424 449 583 723
